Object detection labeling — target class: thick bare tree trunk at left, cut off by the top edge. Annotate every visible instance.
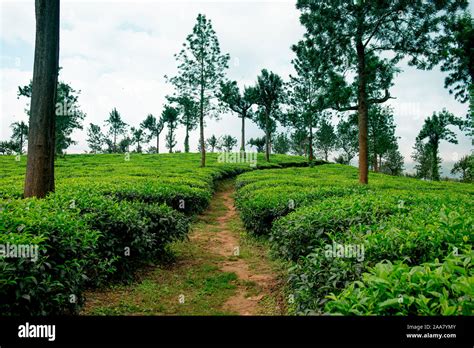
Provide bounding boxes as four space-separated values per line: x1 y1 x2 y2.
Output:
24 0 60 198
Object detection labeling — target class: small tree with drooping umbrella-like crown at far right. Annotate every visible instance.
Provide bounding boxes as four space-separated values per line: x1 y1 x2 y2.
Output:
417 109 463 180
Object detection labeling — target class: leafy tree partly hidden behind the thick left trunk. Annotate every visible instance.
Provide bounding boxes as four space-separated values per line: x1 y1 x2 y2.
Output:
18 81 86 155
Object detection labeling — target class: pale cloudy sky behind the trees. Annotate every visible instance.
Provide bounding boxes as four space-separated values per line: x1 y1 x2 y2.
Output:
0 0 474 175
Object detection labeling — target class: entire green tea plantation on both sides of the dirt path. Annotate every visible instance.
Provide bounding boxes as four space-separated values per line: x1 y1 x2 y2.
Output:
0 154 474 315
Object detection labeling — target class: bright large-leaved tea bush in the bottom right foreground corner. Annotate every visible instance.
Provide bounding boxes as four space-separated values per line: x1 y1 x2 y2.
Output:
325 250 474 316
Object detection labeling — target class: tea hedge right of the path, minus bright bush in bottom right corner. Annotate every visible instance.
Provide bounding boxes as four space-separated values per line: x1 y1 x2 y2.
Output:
237 165 474 315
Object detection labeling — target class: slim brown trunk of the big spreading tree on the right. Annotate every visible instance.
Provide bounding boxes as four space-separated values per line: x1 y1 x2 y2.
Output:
356 40 369 185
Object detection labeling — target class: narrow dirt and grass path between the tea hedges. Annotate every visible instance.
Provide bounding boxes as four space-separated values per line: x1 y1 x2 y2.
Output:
82 180 286 315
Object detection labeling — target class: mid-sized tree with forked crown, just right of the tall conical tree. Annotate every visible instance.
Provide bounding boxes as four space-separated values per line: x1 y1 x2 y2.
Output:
219 81 256 152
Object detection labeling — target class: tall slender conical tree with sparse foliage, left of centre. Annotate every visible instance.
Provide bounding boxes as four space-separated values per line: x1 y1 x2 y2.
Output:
170 14 229 167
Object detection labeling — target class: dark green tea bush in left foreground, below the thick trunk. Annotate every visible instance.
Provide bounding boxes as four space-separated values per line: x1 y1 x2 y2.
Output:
0 199 100 315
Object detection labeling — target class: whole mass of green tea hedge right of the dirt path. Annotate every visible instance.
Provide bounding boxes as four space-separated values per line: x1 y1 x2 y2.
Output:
237 165 474 315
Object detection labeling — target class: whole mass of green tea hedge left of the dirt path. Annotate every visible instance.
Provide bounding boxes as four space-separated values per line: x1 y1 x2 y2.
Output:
0 154 305 315
